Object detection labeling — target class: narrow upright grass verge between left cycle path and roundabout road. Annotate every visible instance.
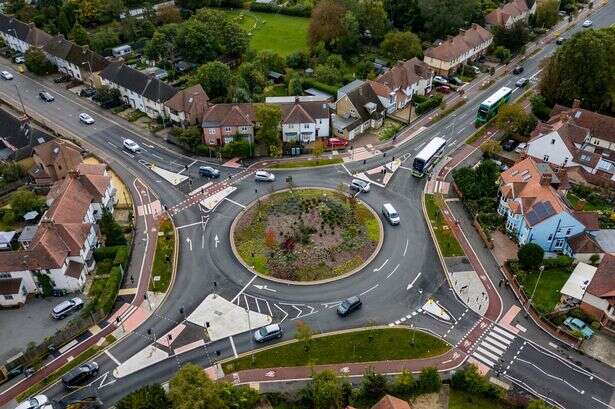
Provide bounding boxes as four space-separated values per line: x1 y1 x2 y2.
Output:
149 218 175 293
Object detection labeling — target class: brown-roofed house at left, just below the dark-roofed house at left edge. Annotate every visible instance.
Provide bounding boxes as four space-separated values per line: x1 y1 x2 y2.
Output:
28 139 82 186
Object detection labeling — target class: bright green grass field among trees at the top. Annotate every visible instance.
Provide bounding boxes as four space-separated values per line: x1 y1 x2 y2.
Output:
228 10 310 56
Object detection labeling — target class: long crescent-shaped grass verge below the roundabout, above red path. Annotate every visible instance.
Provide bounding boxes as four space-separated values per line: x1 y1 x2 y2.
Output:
222 328 450 374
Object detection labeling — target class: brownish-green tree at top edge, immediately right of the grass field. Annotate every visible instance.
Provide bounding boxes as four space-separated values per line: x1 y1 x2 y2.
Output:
308 0 346 46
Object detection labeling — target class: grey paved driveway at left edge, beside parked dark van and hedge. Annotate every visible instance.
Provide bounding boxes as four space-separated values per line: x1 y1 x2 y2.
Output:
0 294 75 362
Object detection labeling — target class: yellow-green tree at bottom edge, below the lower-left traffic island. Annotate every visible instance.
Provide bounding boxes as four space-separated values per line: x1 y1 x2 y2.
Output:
169 364 227 409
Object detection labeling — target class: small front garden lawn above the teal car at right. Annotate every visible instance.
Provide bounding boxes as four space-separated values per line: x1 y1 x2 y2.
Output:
517 269 570 314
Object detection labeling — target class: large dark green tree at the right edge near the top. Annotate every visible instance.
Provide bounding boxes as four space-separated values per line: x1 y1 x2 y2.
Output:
539 27 615 112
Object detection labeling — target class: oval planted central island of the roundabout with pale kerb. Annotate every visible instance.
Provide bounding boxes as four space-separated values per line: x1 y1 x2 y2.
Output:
230 188 383 284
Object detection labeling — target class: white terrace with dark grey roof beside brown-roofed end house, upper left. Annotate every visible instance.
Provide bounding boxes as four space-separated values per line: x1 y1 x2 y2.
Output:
99 62 177 118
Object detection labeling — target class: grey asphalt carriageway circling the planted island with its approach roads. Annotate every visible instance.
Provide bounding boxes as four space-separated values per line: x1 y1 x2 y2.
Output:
0 3 615 408
